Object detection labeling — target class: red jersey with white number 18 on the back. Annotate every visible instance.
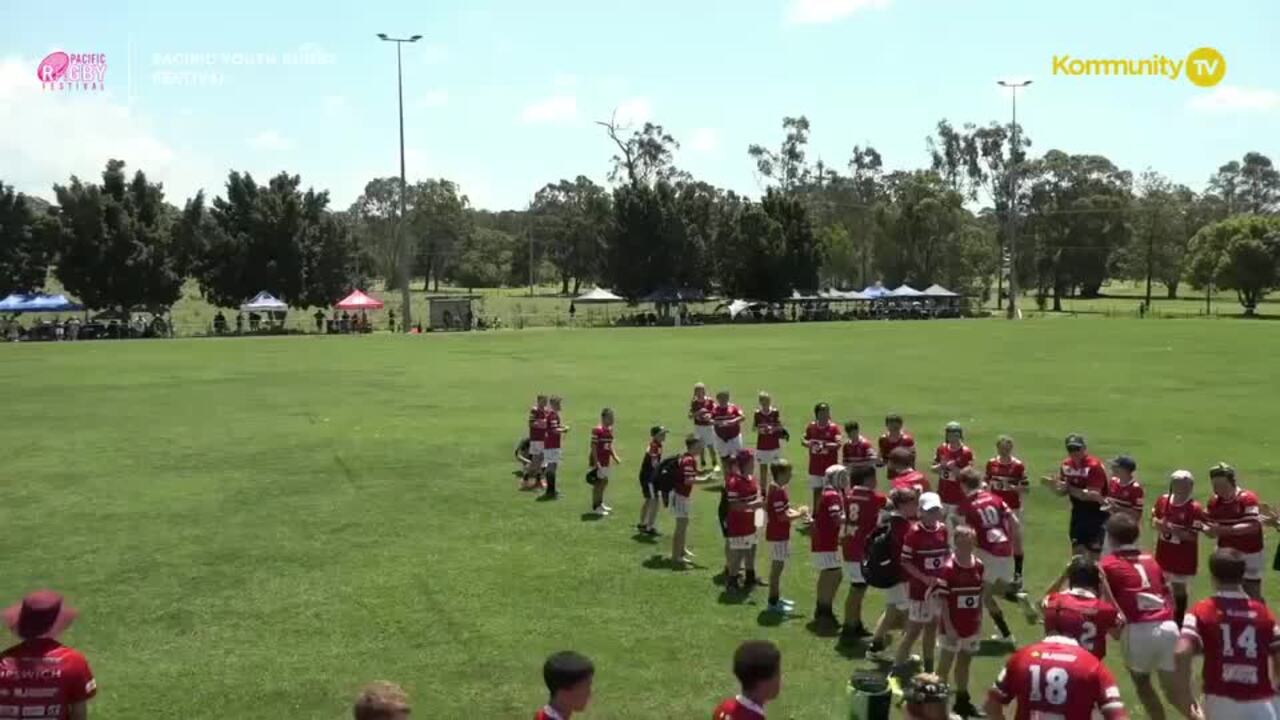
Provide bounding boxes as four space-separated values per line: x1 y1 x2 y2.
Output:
991 635 1129 720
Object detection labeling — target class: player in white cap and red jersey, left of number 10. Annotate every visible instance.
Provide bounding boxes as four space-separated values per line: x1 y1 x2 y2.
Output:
892 492 951 680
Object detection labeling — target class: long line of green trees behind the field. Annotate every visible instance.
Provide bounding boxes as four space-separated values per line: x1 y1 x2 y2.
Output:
0 117 1280 313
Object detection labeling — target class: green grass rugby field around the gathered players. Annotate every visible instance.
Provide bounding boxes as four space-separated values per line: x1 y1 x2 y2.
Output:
0 319 1280 720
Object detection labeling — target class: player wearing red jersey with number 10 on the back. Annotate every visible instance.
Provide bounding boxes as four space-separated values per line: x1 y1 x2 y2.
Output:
960 468 1039 647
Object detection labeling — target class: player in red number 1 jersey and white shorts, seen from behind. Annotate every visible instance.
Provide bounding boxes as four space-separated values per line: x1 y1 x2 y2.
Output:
1101 514 1178 720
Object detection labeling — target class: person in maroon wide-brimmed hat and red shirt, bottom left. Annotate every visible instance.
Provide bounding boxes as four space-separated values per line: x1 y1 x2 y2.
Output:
0 591 97 720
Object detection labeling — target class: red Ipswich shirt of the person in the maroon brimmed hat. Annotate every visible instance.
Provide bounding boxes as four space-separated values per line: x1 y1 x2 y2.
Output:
0 638 97 720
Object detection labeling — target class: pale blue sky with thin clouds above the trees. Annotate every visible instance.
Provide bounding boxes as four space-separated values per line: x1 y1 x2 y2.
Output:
0 0 1280 209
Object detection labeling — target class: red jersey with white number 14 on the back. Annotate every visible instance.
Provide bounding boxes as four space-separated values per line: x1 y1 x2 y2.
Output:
1183 591 1280 702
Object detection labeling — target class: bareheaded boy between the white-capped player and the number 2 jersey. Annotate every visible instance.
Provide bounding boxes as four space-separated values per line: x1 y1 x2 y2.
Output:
934 525 986 717
